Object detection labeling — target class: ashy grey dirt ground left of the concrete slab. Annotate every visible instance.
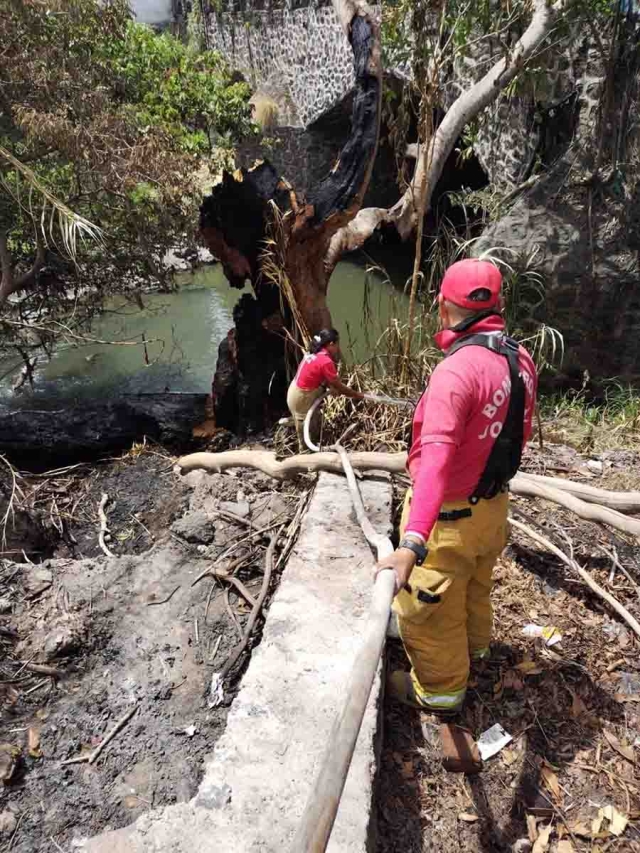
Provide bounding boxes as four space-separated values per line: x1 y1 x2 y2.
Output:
0 449 299 853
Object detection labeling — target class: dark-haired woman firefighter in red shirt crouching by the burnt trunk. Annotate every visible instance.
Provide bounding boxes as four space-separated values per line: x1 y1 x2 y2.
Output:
287 329 364 453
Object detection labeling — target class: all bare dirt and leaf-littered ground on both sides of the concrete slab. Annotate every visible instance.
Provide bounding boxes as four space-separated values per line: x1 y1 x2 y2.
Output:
0 436 640 853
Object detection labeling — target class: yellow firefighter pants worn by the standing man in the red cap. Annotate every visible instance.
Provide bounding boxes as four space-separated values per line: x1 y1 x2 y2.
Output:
393 489 509 711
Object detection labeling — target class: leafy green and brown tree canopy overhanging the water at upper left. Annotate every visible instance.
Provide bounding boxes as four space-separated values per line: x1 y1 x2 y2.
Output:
0 0 254 370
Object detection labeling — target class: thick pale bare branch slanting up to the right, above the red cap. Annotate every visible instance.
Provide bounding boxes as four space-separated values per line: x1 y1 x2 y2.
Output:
329 0 567 256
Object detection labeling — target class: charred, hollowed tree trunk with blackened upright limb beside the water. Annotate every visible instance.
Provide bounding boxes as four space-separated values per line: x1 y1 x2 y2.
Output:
200 0 382 432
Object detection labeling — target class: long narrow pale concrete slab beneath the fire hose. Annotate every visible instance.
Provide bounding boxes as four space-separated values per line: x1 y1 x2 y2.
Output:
80 474 391 853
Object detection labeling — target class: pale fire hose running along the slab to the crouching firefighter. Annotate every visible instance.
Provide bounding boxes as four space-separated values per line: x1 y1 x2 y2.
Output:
290 395 400 853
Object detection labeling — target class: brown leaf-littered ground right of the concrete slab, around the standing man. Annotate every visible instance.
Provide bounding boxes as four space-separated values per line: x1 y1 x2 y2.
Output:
377 445 640 853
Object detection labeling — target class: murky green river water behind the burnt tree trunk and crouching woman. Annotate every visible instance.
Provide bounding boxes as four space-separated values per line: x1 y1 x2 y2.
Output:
0 253 407 403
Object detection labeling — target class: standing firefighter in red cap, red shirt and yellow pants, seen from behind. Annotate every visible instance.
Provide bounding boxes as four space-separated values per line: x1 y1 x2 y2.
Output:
378 260 537 715
